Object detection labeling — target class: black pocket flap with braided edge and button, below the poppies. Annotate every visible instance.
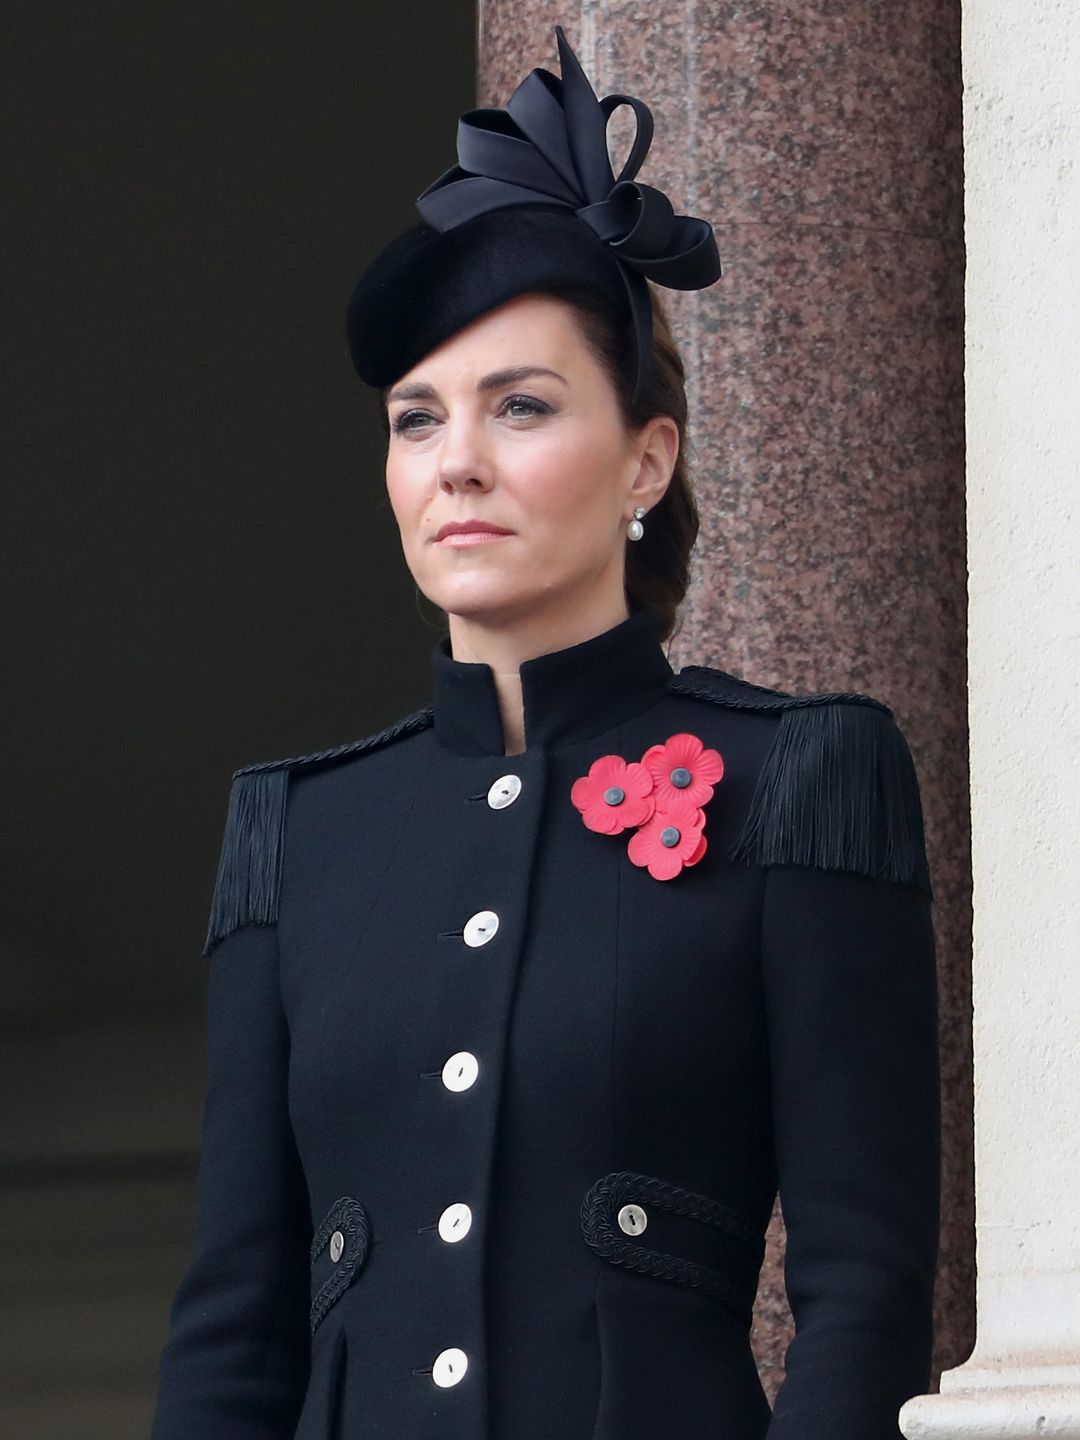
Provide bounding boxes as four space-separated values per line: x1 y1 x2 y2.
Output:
582 1171 765 1320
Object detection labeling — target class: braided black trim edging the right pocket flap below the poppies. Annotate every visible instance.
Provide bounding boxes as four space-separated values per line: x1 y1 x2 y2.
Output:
582 1171 765 1325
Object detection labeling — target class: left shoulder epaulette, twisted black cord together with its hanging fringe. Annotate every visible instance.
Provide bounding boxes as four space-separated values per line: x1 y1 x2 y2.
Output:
203 706 433 955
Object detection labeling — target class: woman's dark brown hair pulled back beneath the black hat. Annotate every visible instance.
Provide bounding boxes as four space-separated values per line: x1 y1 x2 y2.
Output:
379 285 700 639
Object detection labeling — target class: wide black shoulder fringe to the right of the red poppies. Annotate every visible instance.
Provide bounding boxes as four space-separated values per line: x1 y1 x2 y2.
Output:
729 697 933 896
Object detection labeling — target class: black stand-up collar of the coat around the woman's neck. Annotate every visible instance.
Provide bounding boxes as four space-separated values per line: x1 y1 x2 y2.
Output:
432 611 672 755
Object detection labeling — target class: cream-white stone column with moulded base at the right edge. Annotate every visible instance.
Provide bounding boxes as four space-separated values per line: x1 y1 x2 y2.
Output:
901 0 1080 1440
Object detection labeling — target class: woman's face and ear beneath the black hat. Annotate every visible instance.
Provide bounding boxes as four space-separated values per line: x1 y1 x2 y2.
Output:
386 294 678 625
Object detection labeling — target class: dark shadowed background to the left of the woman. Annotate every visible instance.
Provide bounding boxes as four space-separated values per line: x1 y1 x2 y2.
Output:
0 0 475 1440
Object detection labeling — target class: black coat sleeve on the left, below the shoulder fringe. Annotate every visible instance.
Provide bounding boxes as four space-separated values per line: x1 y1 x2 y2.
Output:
153 924 311 1440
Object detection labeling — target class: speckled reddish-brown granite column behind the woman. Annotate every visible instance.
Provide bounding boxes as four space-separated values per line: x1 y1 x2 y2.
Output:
478 0 972 1391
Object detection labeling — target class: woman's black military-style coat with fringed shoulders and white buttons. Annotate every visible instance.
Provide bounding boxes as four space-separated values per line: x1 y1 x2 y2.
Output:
153 615 939 1440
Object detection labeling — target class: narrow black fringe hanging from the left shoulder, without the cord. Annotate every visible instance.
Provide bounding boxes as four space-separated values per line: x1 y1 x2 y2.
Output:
203 769 289 955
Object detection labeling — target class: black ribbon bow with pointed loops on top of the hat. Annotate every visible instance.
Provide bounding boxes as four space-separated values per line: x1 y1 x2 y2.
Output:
416 26 721 399
